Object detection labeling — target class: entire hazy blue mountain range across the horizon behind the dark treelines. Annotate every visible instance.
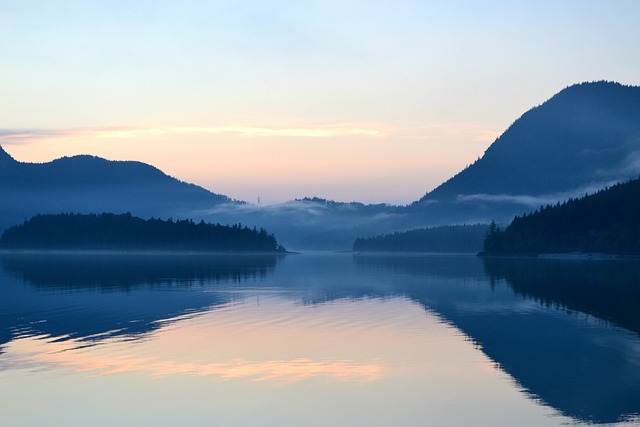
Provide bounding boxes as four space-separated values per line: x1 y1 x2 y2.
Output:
0 81 640 249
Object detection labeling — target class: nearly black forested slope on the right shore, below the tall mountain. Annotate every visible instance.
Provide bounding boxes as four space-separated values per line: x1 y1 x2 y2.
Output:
481 179 640 255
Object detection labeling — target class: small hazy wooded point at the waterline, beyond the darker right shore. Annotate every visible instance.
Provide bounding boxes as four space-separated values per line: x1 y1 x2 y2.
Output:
353 224 489 253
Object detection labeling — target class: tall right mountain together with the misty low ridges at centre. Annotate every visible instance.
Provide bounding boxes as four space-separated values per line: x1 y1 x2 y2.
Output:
181 82 640 249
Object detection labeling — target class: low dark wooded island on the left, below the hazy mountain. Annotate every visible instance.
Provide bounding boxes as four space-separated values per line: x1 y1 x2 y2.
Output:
0 213 285 252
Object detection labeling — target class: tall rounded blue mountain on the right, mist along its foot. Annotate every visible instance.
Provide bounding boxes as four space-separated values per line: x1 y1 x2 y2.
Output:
418 81 640 204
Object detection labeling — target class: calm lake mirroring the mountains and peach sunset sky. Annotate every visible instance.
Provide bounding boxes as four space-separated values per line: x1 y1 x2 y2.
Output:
0 253 640 427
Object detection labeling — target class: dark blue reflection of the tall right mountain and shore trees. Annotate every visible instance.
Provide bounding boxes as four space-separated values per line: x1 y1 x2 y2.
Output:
355 256 640 423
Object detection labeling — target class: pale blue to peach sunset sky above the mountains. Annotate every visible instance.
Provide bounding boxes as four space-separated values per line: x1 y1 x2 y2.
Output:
0 0 640 204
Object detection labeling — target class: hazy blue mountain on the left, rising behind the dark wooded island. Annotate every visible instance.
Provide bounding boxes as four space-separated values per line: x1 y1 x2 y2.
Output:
0 147 233 232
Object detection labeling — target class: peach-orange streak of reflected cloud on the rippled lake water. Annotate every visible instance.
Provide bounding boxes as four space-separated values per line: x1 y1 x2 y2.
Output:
11 332 384 382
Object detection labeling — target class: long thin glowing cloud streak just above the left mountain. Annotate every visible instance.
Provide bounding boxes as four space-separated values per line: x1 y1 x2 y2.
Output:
0 125 382 144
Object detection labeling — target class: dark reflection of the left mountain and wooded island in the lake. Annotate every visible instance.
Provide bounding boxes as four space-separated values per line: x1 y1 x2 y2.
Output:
0 253 279 352
